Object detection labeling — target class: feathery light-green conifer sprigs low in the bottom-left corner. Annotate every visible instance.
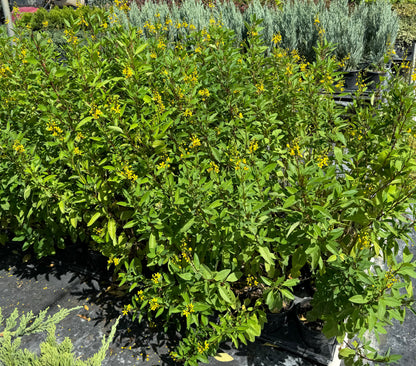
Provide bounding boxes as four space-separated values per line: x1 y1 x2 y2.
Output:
0 308 119 366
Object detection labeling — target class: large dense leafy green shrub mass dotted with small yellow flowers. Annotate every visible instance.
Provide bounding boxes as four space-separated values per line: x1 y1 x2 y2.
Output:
0 8 416 365
